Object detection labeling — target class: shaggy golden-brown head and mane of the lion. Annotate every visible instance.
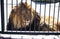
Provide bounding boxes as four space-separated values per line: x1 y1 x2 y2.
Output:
7 3 38 29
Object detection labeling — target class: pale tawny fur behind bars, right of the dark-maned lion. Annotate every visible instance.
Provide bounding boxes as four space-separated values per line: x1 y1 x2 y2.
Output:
40 16 60 31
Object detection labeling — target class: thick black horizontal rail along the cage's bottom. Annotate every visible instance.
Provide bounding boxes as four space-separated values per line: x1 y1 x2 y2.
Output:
1 32 60 35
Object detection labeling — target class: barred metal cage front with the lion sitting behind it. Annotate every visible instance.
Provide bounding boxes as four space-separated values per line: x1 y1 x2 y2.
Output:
1 0 60 34
